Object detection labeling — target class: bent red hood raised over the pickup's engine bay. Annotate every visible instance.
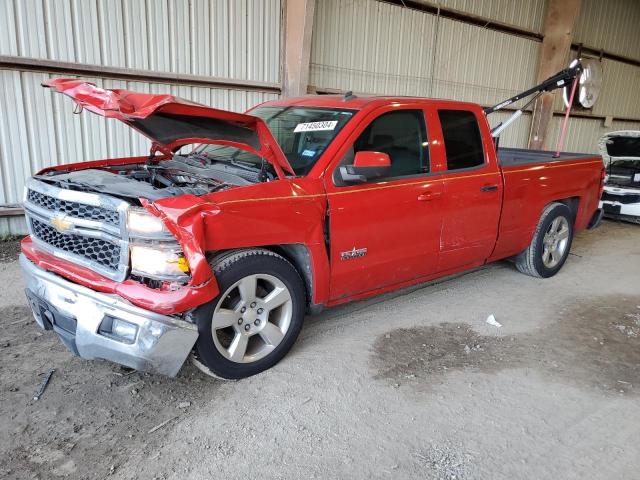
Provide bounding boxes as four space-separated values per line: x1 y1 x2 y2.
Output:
42 78 294 178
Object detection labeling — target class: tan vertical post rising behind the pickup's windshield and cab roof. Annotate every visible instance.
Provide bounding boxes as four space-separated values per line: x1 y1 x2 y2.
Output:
282 0 315 97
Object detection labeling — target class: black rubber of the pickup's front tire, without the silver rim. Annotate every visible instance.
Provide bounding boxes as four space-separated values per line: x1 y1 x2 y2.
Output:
192 249 306 380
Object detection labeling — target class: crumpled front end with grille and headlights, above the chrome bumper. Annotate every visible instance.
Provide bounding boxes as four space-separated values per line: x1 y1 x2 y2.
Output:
22 179 218 315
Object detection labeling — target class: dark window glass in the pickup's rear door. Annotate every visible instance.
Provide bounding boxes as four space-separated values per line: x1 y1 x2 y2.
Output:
438 110 484 170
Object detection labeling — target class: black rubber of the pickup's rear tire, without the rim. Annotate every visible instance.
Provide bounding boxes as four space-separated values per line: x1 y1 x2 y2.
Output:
514 202 574 278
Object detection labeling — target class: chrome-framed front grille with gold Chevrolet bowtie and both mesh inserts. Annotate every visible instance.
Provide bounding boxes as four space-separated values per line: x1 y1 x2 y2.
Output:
24 179 129 281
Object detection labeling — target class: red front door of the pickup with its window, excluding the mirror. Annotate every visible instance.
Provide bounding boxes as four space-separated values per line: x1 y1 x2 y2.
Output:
326 108 443 301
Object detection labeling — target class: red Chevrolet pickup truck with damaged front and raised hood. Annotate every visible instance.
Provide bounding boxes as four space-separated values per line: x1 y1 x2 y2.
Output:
20 79 604 378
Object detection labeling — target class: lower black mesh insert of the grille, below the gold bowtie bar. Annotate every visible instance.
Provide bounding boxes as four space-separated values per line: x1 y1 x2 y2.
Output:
30 218 121 271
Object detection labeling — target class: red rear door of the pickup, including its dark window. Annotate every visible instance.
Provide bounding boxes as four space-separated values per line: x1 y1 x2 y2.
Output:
434 104 503 271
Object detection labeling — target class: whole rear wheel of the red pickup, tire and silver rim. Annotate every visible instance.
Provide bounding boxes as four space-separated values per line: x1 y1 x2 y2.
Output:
515 202 573 278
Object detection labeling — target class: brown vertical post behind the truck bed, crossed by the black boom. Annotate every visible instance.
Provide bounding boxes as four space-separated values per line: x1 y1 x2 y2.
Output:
529 0 581 150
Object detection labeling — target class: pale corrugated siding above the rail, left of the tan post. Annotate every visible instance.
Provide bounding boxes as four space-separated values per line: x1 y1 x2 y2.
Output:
0 0 281 83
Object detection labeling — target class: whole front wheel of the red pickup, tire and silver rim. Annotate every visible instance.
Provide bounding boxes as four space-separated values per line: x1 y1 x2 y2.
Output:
192 249 306 379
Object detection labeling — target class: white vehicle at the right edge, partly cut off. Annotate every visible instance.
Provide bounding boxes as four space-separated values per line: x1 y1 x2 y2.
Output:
598 130 640 223
